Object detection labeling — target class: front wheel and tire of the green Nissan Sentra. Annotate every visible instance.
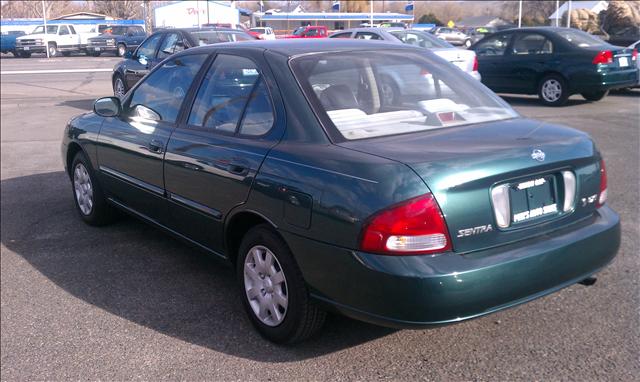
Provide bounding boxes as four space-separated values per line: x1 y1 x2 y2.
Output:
69 151 116 226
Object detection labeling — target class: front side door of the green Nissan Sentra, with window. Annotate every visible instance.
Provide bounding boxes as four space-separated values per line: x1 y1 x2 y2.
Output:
97 53 207 223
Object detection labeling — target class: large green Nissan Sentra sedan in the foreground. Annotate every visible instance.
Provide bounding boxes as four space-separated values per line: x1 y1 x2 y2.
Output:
62 39 620 343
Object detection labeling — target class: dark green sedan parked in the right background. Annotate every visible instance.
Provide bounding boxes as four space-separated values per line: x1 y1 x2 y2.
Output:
469 27 638 106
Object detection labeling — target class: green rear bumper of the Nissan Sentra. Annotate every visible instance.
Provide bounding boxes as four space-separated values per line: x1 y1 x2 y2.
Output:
283 206 620 328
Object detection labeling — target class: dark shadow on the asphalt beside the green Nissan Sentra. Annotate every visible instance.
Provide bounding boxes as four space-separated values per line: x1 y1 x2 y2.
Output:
0 171 394 362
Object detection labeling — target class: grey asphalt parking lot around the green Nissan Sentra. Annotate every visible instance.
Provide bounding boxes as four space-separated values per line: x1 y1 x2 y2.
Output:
0 55 640 381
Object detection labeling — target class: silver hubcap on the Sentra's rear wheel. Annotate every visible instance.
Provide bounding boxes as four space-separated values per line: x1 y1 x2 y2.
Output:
244 245 289 326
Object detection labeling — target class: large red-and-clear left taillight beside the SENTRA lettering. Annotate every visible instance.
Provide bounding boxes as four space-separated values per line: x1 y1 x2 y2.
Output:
360 194 451 255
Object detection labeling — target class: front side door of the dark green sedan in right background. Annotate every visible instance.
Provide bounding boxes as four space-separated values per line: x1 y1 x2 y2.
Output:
473 33 513 91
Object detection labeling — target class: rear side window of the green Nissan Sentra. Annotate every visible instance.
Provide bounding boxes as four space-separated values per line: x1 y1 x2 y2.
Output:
189 54 273 135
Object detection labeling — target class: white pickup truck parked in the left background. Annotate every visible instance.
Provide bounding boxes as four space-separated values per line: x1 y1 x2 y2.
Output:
16 24 98 58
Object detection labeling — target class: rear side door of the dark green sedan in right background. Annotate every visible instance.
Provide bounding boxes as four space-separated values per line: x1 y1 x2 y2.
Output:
504 32 556 93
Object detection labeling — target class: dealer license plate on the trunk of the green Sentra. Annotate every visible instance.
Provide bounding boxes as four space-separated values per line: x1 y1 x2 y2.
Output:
509 175 560 226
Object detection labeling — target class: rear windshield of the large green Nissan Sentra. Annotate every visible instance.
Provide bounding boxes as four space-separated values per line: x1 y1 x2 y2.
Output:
291 50 518 140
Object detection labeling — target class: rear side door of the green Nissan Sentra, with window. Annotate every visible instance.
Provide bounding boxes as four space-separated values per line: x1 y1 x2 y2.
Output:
164 53 284 253
